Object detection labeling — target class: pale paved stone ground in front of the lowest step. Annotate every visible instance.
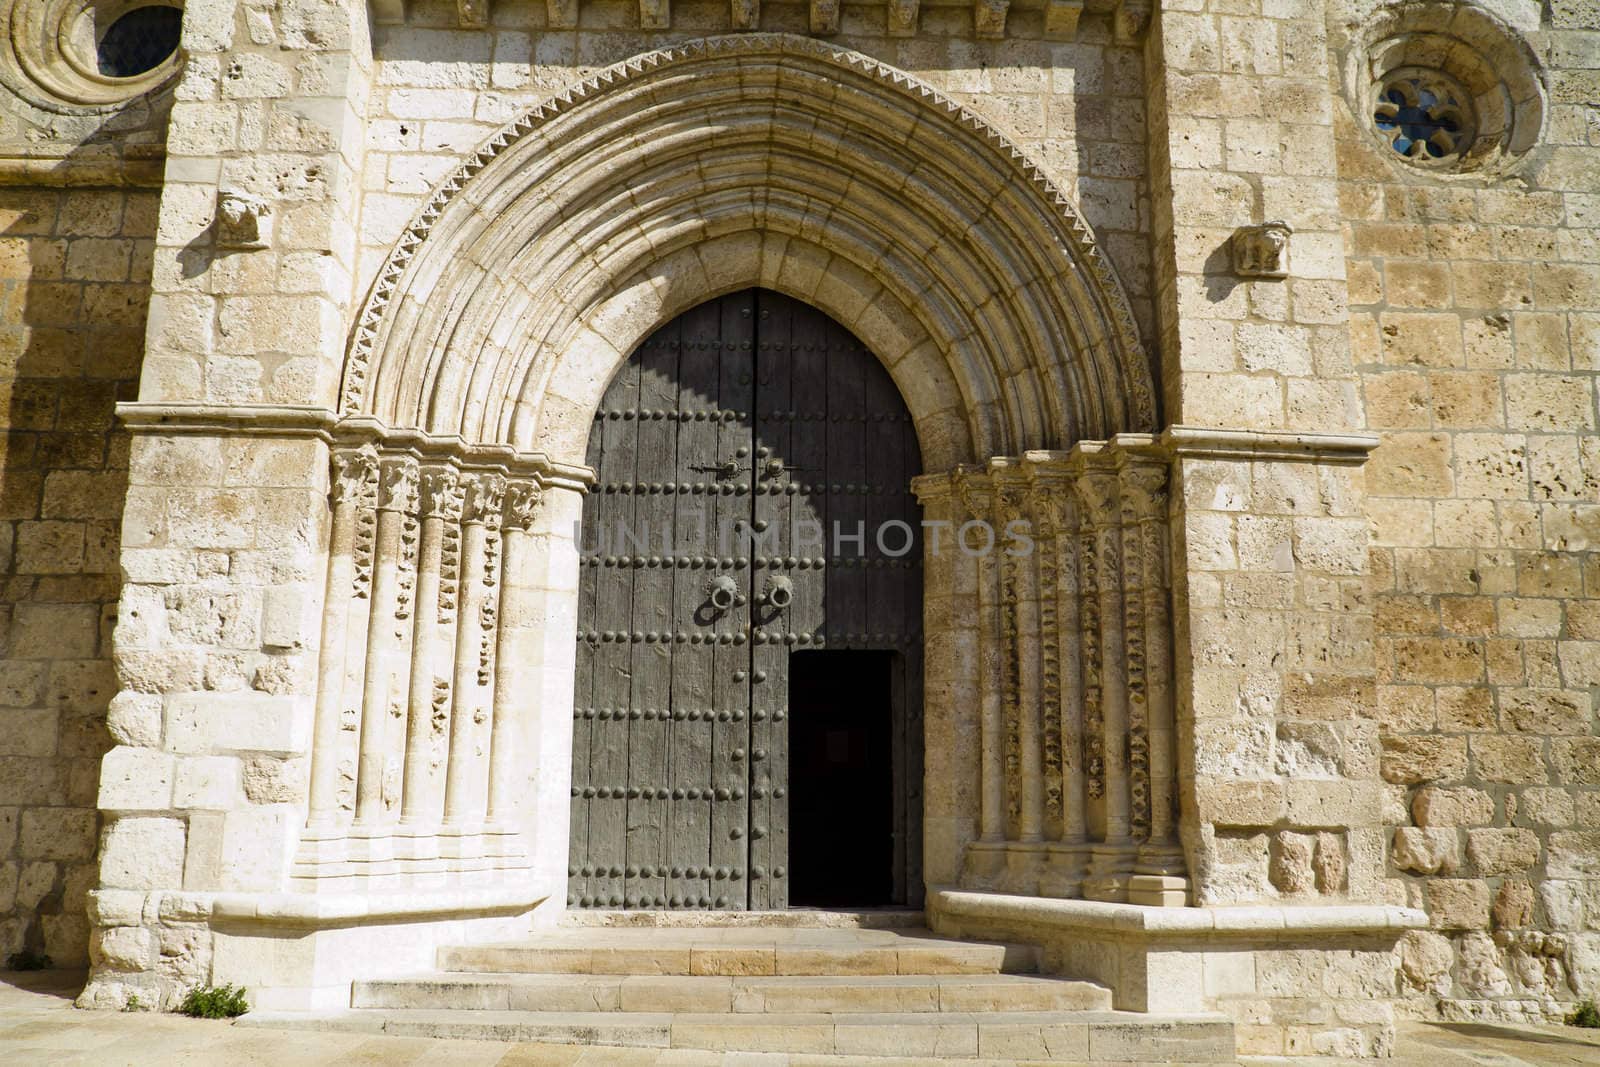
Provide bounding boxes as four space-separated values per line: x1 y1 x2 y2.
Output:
0 971 1600 1067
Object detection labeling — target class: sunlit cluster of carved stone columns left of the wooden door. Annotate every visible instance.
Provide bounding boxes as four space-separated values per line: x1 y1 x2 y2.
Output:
294 443 571 886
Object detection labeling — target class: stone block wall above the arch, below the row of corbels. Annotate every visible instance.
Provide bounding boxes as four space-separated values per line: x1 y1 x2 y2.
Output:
357 0 1152 355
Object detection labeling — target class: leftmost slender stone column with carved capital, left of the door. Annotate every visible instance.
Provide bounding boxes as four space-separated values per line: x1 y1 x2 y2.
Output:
307 448 378 827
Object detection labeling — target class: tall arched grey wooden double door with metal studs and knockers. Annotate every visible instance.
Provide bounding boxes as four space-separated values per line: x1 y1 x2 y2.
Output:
568 290 922 910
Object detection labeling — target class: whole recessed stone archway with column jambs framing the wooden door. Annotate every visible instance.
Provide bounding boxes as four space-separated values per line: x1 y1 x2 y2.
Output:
315 34 1182 921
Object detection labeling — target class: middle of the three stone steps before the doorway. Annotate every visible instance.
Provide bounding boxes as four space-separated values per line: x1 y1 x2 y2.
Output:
350 974 1110 1014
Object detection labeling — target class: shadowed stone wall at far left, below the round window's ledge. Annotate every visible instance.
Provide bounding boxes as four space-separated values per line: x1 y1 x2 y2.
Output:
0 189 157 966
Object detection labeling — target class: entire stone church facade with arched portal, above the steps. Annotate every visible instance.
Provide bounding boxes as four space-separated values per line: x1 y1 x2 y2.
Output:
0 0 1600 1054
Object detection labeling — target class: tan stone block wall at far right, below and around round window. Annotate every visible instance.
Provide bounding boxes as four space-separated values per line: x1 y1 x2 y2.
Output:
1330 0 1600 1017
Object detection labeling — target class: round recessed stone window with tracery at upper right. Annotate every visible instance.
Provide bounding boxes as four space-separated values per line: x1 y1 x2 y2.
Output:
1346 2 1546 178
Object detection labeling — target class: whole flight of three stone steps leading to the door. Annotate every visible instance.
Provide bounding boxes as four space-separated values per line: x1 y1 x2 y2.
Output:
242 913 1235 1064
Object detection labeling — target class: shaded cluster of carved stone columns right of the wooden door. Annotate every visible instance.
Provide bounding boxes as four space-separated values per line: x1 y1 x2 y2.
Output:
914 435 1187 904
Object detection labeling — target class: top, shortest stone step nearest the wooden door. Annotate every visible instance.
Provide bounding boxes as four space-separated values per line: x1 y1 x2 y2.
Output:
438 928 1038 976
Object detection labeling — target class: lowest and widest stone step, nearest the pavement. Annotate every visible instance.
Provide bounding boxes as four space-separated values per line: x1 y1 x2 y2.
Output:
238 1009 1237 1064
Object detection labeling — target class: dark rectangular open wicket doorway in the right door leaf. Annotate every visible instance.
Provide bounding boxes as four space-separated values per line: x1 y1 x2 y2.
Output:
789 651 901 907
